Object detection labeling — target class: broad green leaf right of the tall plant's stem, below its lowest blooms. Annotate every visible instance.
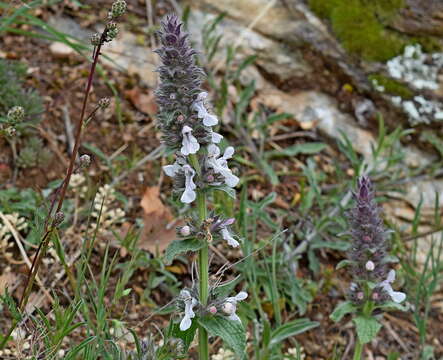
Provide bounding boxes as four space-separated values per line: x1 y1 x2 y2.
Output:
197 316 246 359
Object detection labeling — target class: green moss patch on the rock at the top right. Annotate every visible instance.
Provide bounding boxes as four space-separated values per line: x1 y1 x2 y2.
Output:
309 0 409 62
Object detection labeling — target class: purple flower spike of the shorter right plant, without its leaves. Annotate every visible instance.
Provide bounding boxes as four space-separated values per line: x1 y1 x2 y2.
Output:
348 177 406 303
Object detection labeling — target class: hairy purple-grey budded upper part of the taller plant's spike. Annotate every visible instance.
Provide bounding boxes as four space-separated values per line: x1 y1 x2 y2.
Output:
155 15 211 152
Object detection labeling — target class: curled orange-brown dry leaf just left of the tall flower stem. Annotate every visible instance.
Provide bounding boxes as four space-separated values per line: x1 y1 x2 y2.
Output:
139 186 182 254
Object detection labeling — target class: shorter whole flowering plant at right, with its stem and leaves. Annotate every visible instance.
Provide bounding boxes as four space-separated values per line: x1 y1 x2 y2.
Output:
331 176 406 360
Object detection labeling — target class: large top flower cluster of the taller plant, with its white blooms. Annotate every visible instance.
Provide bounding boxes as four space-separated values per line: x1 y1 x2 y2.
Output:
156 15 239 204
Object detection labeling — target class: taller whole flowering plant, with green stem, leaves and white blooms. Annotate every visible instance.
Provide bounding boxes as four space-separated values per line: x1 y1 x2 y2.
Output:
156 15 248 360
